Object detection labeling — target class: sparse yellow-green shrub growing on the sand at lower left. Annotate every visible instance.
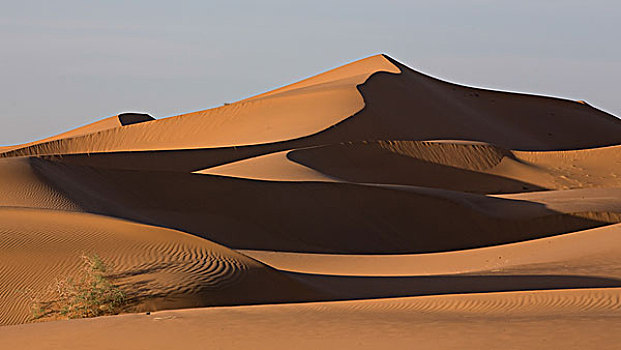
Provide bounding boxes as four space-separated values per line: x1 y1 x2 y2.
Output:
19 254 127 319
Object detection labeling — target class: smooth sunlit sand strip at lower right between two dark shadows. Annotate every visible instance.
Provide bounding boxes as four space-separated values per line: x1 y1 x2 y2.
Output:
239 224 621 279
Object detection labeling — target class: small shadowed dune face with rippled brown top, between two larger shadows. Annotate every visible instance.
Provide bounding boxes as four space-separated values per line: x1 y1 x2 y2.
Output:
288 141 544 193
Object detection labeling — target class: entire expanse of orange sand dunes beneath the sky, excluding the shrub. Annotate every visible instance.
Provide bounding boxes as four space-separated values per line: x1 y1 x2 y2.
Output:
0 55 621 349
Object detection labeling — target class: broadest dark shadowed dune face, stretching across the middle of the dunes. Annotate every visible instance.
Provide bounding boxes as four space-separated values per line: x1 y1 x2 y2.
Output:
17 160 621 254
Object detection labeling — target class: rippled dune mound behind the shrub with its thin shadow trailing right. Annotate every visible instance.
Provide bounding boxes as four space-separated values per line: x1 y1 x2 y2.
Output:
0 208 620 324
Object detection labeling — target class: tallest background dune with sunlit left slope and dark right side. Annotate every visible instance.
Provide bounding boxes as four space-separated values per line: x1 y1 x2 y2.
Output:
2 55 621 157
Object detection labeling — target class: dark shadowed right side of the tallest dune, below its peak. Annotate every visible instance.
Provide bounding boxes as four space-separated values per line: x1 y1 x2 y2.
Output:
310 57 621 150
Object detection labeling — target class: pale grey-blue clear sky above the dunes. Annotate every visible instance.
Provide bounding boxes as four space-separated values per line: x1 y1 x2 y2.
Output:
0 0 621 145
